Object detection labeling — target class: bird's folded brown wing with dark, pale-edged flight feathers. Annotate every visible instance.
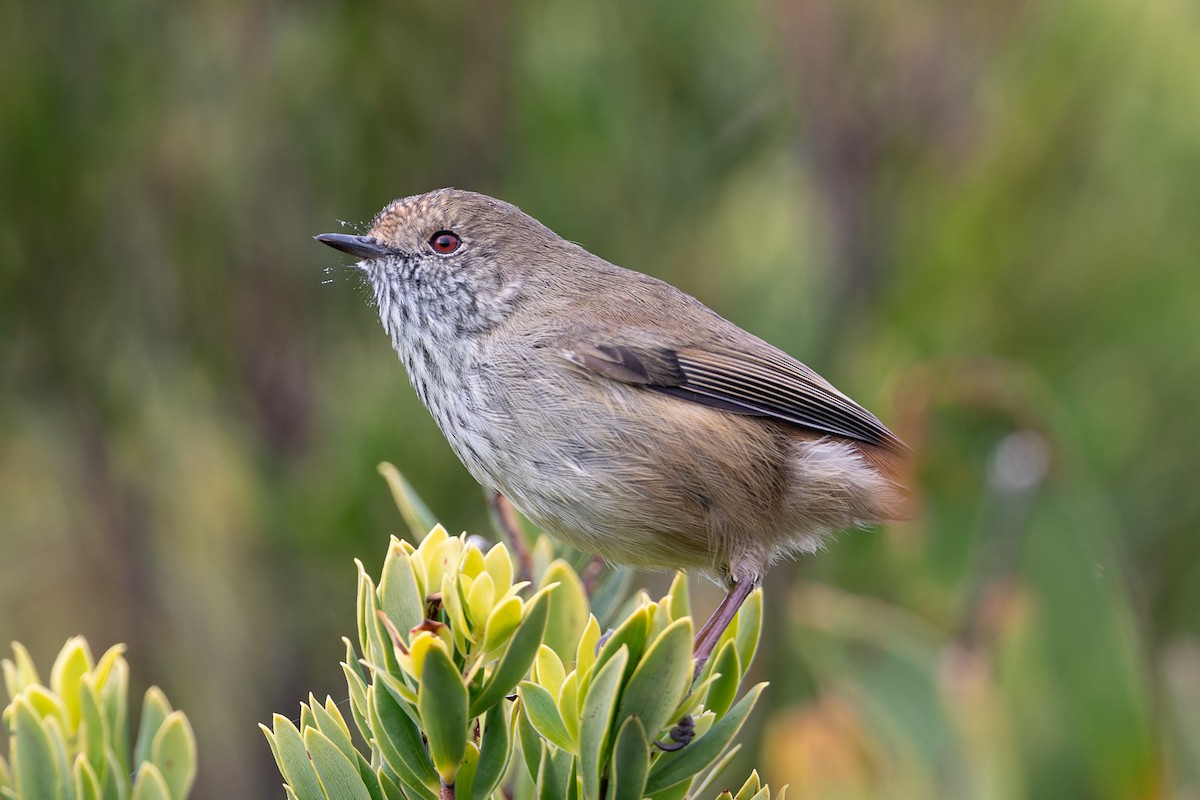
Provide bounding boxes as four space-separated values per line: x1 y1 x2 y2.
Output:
556 336 905 451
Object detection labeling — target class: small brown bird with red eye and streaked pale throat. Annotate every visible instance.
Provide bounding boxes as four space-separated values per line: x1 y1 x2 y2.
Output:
317 188 907 673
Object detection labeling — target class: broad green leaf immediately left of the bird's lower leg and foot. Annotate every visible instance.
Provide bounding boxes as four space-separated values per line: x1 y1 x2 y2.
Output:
617 616 692 738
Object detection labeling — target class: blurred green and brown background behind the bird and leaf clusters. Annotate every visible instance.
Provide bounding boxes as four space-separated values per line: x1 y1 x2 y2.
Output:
0 0 1200 798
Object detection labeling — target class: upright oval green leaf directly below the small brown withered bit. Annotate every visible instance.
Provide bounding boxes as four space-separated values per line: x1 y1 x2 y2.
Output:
416 645 468 784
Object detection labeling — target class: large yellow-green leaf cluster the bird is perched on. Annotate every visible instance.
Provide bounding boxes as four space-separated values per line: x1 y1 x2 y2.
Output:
263 510 769 800
